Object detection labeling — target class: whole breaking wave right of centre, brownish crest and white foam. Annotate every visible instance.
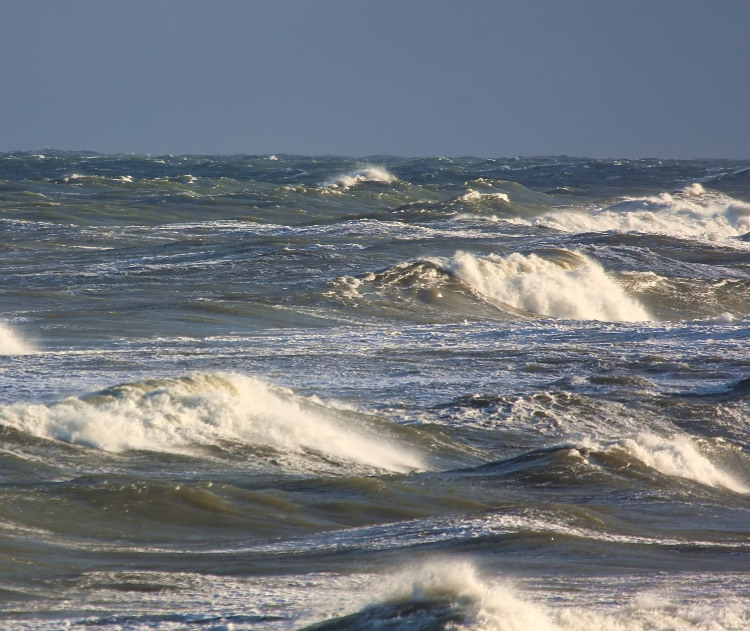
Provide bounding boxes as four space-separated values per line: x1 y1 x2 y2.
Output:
333 249 651 321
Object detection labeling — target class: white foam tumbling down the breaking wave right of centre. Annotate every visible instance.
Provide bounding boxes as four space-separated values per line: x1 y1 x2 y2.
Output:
452 252 650 322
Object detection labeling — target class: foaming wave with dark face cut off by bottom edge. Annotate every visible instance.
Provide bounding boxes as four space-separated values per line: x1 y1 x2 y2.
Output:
305 558 747 631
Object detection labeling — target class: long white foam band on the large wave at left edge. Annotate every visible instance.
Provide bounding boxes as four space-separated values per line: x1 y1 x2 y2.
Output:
0 373 423 472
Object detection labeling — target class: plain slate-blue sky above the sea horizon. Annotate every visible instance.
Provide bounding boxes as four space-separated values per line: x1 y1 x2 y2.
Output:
0 0 750 159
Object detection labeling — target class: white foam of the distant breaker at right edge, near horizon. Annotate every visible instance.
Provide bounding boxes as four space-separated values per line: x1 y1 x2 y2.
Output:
534 183 750 241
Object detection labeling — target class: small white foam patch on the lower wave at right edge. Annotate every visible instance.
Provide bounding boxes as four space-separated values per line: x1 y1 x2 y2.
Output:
606 432 750 494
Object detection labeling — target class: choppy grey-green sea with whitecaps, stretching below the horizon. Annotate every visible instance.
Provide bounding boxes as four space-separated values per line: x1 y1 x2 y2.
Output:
0 151 750 631
